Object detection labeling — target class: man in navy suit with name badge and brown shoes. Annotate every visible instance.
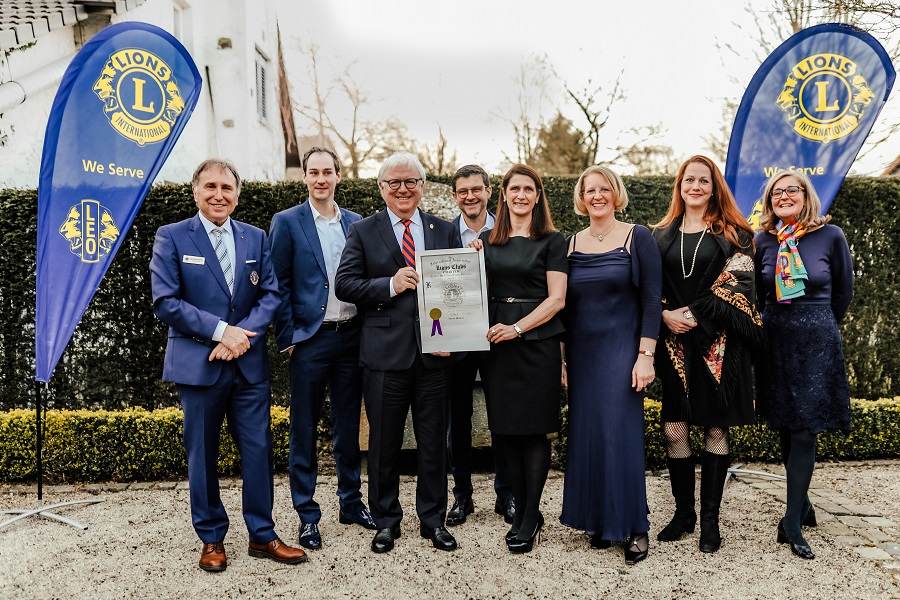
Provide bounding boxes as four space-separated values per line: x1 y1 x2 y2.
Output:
150 159 306 571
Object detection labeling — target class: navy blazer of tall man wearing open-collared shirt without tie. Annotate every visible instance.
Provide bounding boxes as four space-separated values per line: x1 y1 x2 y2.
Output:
269 199 362 350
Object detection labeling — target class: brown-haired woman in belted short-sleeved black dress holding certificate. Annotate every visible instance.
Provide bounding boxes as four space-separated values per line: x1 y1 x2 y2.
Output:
469 165 569 552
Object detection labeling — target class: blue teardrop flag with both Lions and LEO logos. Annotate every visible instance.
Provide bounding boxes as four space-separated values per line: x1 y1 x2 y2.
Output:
35 22 202 382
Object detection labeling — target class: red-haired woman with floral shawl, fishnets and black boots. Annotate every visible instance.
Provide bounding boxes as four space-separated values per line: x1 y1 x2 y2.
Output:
653 156 763 552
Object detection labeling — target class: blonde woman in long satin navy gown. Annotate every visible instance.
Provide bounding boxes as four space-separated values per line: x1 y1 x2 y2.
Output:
560 166 662 564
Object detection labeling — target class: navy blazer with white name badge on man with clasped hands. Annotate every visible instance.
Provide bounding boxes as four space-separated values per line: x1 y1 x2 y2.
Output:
150 215 278 386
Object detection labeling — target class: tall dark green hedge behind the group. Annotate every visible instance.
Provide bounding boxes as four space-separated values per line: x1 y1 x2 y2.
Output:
0 177 900 410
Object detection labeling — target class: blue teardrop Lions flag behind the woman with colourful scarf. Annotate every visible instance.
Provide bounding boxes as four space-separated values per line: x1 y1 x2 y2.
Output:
725 23 896 228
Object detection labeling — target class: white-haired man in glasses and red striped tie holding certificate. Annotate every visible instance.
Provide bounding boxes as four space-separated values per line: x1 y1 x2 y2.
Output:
335 153 462 552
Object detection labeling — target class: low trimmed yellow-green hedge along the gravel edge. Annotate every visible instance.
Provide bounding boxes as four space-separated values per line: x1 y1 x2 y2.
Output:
0 398 900 482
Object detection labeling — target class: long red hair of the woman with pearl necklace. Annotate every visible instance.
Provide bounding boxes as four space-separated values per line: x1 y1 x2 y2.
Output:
653 154 753 248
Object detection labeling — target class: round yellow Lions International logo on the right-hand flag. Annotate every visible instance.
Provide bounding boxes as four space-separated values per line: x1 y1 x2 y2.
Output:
775 54 875 144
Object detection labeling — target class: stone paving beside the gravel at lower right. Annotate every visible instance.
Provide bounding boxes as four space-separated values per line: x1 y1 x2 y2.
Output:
734 461 900 583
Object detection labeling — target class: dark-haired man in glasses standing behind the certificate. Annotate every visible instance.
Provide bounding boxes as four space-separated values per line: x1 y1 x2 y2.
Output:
447 165 516 525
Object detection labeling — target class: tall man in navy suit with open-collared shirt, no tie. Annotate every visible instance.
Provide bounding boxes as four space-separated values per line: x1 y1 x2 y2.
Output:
269 147 375 550
